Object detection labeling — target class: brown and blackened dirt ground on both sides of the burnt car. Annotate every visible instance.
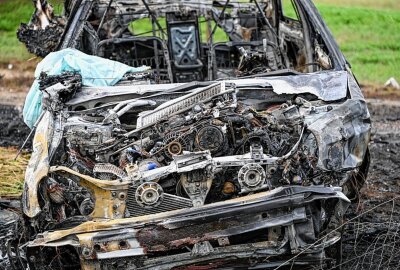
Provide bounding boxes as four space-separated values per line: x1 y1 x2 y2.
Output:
0 67 400 270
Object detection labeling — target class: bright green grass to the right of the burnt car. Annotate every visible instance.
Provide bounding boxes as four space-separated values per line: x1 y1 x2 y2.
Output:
317 1 400 84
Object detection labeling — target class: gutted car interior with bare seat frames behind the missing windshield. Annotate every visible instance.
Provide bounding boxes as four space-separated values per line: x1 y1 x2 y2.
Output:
19 0 333 83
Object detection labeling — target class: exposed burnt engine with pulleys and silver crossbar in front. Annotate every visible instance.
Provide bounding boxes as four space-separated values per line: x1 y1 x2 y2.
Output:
53 83 317 216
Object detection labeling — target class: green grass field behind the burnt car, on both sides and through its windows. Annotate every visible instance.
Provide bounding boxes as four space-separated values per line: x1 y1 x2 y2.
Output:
0 0 400 84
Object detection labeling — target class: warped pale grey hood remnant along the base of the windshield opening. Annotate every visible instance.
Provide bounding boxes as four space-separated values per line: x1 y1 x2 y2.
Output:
66 71 348 106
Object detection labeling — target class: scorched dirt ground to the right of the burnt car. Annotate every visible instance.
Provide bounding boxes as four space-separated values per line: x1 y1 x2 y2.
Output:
342 99 400 270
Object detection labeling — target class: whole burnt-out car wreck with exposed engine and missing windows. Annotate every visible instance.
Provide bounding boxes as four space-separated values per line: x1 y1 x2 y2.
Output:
14 0 371 269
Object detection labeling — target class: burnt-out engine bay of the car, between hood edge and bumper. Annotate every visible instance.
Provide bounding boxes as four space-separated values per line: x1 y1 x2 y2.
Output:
36 79 356 226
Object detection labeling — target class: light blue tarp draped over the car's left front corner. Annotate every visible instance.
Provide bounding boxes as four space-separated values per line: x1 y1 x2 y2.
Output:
23 49 148 128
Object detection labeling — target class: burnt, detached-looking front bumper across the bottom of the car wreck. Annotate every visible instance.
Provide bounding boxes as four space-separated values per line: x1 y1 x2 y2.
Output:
27 186 349 269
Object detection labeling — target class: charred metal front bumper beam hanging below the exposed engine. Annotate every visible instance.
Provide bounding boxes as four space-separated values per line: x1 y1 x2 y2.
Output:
29 187 348 269
